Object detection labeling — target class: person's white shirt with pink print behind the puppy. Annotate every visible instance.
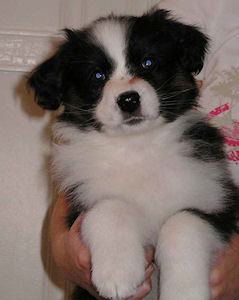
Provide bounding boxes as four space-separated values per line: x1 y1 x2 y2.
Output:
159 0 239 184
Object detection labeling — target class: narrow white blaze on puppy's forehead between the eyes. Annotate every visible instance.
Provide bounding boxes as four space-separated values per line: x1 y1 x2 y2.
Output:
93 19 129 79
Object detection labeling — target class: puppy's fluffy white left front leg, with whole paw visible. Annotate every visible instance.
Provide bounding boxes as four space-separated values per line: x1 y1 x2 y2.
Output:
82 200 145 299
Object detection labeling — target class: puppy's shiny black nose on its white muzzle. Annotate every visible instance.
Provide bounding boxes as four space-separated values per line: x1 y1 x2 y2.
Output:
117 91 140 113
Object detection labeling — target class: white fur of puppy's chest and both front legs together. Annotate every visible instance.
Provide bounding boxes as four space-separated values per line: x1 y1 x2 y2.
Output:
54 111 226 300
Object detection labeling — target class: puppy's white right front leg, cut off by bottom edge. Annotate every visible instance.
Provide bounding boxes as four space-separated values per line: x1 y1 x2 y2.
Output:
156 211 222 300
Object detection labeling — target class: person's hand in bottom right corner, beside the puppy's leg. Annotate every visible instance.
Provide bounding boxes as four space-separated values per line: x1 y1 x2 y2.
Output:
210 234 239 300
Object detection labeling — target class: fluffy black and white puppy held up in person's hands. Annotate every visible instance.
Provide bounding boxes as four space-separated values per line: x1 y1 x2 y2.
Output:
29 10 238 300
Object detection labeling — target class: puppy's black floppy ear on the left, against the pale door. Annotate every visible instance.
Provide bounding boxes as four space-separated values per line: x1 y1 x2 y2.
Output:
27 54 62 110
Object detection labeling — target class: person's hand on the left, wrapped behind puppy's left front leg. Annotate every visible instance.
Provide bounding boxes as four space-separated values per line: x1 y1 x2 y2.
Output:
50 196 153 300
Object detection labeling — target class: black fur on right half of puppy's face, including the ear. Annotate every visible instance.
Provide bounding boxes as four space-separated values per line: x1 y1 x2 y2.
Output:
126 10 208 121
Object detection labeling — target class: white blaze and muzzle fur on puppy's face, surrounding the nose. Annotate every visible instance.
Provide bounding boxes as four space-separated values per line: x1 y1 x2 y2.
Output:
93 20 162 131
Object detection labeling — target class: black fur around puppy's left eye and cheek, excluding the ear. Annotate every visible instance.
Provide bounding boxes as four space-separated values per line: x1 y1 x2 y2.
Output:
59 30 114 129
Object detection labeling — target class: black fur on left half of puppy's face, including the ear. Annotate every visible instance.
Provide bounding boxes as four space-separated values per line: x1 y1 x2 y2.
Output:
28 29 114 129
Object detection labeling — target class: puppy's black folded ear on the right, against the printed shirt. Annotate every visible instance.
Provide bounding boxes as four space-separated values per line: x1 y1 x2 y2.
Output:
175 23 209 74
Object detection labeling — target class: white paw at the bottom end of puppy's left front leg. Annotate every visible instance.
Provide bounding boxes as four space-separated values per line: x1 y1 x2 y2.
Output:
92 252 145 300
